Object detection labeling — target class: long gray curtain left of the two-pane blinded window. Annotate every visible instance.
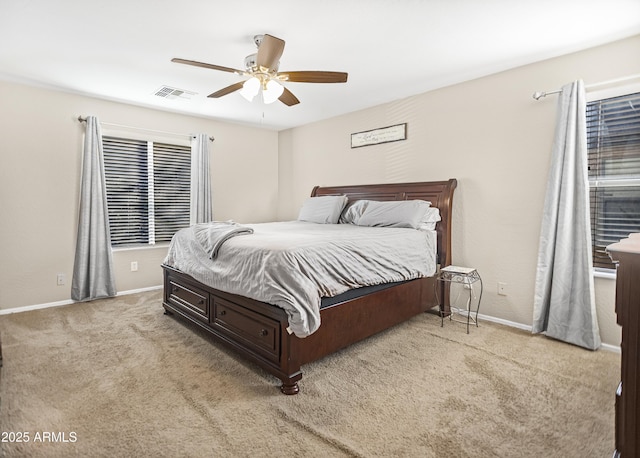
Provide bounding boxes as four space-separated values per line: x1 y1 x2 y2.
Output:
71 116 116 301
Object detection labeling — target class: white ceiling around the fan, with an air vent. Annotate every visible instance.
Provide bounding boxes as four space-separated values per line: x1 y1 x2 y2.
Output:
0 0 640 130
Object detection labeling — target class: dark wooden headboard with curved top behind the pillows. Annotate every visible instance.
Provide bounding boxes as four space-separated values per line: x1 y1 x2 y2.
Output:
311 178 458 267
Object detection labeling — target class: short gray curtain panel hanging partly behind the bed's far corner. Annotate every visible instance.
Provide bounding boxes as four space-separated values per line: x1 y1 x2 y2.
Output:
190 134 213 224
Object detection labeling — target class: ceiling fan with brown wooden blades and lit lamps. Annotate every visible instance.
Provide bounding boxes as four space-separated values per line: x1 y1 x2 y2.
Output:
171 34 348 106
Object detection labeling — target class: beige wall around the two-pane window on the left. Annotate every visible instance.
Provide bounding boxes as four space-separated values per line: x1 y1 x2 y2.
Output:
0 82 278 309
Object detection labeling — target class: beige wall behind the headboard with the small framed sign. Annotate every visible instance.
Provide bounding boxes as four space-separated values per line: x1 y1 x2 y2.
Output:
278 36 640 345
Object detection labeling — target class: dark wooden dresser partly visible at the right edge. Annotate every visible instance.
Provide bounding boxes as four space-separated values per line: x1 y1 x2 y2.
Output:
607 233 640 458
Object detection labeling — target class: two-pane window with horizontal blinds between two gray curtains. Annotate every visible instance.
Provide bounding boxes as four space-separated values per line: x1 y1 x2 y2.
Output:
102 135 191 247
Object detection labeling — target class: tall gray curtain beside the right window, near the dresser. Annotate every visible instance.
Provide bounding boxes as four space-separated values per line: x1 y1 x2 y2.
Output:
533 81 600 350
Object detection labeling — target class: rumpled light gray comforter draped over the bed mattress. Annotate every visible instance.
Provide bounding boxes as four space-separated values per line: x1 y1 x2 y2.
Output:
164 221 436 337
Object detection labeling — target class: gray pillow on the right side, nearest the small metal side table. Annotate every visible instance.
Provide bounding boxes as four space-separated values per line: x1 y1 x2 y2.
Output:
358 200 431 229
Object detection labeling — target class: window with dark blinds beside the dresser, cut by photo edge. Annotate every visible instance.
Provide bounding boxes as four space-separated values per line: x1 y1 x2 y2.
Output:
587 92 640 269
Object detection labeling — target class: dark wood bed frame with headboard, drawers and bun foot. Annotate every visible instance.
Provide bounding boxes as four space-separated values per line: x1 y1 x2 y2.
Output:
162 179 457 394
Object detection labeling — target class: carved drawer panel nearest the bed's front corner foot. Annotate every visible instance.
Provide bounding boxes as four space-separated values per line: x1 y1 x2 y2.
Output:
211 297 280 362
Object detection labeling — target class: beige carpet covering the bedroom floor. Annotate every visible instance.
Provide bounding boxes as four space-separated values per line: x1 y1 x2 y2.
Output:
0 291 620 458
